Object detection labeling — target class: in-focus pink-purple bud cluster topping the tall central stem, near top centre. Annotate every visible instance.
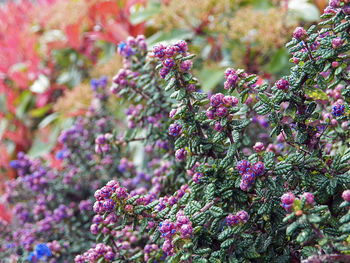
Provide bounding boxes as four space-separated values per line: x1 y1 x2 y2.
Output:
153 40 192 78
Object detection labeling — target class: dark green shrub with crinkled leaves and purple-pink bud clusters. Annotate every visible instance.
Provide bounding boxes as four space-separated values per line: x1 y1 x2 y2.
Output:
0 0 350 263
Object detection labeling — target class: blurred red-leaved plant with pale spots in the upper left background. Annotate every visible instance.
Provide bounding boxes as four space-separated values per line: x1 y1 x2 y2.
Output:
0 0 145 186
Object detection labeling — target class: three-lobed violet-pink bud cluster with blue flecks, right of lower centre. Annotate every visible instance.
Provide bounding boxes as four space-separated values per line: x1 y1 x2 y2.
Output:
237 160 265 191
